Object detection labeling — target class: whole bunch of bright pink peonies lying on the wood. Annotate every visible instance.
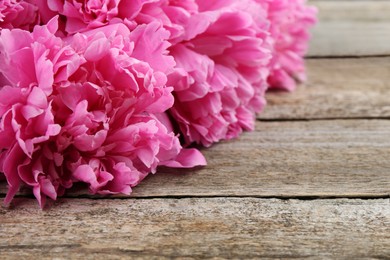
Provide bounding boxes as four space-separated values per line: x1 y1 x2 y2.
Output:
0 0 316 207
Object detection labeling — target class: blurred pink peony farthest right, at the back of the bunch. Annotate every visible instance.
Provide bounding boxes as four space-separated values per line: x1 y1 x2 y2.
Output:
262 0 317 91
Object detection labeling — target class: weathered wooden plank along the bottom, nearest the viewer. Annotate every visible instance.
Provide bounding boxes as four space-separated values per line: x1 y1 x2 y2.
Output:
0 198 390 259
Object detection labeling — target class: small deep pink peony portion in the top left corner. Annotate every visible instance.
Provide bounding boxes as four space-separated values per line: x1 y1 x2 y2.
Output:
0 0 39 30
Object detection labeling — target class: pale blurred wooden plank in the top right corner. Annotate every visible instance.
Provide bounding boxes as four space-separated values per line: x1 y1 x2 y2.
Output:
308 0 390 57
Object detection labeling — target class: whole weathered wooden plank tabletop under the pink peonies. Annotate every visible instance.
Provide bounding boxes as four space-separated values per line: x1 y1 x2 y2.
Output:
0 1 390 259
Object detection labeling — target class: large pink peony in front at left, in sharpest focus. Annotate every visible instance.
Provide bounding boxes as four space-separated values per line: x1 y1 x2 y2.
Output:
0 19 205 207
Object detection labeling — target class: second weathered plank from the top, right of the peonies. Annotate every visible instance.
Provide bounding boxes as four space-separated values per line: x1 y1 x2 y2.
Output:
259 57 390 119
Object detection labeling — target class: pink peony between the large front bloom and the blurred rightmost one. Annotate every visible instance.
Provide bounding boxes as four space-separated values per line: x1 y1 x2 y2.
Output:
169 0 271 146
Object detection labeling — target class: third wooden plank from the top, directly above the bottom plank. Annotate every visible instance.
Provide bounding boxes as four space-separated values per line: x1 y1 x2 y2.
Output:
2 120 390 197
